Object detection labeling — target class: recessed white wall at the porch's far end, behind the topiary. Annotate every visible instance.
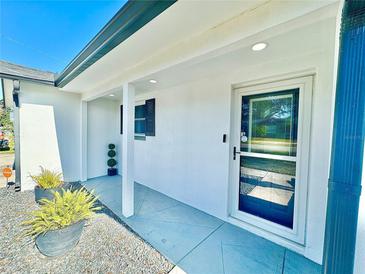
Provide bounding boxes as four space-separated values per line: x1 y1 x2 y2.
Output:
87 98 120 178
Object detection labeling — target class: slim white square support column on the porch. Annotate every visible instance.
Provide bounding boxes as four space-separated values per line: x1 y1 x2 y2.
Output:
122 83 135 217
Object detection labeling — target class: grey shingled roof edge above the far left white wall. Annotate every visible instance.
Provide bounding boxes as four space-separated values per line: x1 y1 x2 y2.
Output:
0 60 55 85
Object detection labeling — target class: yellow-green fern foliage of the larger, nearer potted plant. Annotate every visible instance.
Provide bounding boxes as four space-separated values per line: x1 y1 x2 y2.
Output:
23 188 101 237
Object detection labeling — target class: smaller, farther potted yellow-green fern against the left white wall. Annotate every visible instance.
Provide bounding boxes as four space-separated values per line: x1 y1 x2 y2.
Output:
30 167 67 203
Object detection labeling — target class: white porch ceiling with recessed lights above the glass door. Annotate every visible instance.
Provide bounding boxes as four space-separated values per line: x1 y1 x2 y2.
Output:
97 2 336 101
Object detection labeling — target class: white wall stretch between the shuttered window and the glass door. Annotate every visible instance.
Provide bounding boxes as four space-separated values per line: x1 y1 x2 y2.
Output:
135 79 230 219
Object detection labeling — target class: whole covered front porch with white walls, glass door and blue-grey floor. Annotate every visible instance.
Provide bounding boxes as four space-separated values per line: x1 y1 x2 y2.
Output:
67 1 362 273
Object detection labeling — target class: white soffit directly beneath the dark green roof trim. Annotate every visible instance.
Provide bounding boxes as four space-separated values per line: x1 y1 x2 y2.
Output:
59 0 266 91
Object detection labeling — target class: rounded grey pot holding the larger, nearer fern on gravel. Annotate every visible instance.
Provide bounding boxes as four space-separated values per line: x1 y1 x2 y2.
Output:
35 220 86 257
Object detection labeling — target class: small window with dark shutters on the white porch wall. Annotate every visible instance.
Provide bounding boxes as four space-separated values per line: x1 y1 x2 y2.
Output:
120 99 155 140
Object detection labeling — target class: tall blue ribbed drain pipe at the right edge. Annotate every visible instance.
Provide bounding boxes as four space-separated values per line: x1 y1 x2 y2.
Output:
322 0 365 274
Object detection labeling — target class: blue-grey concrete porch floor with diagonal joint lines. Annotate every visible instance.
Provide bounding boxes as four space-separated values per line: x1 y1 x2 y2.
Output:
82 176 321 274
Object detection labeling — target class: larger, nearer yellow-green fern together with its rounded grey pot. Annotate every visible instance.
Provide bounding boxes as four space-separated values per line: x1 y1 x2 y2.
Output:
22 188 101 256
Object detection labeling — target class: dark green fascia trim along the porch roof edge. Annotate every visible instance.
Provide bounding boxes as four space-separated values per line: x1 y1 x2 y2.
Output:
55 0 177 87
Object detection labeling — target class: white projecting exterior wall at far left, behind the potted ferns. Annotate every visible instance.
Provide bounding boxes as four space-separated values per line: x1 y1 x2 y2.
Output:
19 81 81 184
